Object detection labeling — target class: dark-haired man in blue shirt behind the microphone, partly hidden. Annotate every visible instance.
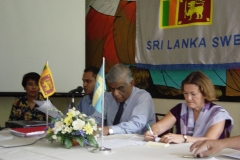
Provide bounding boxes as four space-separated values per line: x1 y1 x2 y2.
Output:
77 66 102 122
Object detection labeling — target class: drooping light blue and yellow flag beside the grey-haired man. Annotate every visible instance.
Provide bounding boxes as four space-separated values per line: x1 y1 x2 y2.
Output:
92 58 106 113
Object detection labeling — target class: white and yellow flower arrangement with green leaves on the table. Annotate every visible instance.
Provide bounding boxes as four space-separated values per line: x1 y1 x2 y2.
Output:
46 107 98 149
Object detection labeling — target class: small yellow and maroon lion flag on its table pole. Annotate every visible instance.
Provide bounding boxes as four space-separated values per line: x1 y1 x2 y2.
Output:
38 61 56 126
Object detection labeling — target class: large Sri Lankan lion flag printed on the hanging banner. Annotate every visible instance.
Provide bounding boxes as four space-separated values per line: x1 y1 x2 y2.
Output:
159 0 213 28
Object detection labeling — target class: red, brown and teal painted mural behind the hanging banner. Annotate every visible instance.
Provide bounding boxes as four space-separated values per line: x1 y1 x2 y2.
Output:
86 0 240 101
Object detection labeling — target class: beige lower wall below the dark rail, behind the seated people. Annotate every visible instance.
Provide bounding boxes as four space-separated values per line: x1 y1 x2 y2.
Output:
0 97 240 136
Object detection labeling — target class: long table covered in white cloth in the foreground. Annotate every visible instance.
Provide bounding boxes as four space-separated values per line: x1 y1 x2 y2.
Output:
0 129 236 160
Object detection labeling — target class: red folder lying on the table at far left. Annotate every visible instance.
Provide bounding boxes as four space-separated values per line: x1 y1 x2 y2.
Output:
10 126 46 137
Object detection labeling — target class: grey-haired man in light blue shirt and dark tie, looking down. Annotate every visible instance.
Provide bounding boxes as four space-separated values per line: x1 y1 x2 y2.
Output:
98 64 155 135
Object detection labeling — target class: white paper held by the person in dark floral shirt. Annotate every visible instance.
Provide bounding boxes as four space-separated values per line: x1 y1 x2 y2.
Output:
33 100 63 118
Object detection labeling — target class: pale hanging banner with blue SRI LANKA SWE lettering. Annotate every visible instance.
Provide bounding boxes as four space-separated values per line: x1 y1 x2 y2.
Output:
135 0 240 69
